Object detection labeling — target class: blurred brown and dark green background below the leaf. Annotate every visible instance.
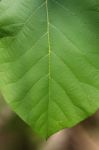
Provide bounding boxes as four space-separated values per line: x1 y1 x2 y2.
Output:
0 96 99 150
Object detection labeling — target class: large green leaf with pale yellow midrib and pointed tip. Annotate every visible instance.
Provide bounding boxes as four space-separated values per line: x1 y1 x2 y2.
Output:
0 0 99 137
